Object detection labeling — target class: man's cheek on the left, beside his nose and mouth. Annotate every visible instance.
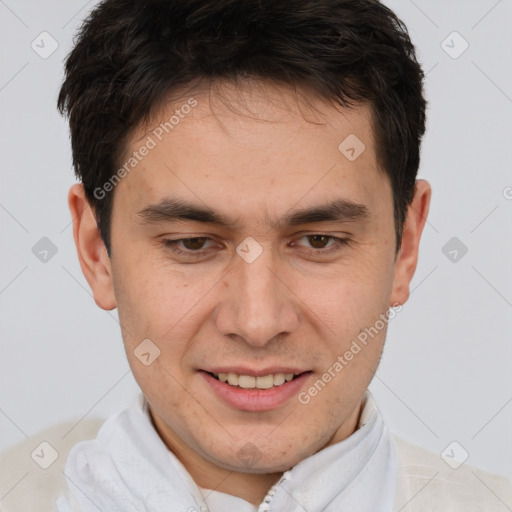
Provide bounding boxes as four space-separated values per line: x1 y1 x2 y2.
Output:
114 263 217 392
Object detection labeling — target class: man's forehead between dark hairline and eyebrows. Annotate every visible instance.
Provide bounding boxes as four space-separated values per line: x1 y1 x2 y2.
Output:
115 82 391 222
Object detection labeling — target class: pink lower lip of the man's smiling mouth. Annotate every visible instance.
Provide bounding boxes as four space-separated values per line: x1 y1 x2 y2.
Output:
199 371 311 412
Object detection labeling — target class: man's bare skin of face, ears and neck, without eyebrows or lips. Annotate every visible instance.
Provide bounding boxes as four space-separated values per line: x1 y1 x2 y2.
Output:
69 82 431 504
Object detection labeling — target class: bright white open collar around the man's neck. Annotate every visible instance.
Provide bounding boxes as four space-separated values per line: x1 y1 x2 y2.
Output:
59 391 396 512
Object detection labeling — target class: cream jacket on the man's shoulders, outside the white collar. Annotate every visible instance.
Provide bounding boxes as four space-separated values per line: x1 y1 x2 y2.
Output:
0 396 512 512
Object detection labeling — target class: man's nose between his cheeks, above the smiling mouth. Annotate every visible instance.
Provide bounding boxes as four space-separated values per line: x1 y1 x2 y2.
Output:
216 241 299 347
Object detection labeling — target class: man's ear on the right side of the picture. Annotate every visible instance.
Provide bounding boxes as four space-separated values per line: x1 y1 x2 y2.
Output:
389 180 432 306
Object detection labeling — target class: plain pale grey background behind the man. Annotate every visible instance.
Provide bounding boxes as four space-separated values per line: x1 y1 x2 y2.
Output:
0 0 512 475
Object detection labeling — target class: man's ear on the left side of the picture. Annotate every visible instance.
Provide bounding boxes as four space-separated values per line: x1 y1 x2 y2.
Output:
68 183 117 310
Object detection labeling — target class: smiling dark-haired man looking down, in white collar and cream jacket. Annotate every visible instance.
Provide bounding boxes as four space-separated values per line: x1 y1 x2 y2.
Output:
2 0 512 512
